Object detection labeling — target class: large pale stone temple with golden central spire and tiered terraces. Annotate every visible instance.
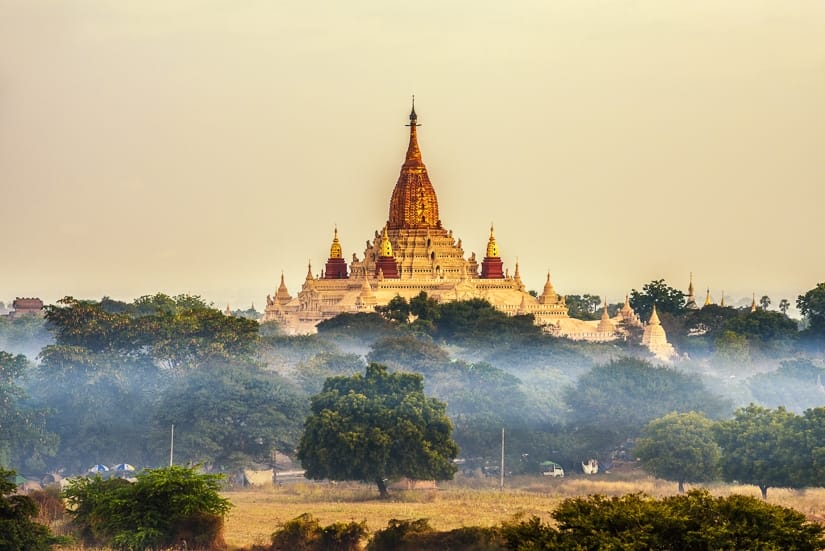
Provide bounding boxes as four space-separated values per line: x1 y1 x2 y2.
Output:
262 103 676 356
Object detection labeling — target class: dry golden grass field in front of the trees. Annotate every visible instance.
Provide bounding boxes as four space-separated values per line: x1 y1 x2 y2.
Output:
224 471 825 548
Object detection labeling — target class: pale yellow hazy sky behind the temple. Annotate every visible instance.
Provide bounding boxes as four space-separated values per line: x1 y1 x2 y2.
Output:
0 0 825 309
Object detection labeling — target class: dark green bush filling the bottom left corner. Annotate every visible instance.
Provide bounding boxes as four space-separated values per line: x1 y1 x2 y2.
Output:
0 467 55 551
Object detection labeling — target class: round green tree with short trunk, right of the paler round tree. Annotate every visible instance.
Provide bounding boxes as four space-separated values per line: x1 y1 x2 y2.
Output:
714 404 802 499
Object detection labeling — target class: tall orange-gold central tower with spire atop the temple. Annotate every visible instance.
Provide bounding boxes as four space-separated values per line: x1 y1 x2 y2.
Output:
388 98 441 230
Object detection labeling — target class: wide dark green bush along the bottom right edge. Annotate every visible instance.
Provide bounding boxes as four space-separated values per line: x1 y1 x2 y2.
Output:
502 490 825 551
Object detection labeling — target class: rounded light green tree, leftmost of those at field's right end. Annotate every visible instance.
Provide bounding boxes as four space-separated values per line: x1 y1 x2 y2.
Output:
633 411 721 493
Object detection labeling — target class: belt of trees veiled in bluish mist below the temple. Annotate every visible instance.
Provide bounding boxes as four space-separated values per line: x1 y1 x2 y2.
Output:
0 281 825 500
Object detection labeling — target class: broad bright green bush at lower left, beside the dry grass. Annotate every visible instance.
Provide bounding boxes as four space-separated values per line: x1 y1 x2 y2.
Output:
64 466 231 550
